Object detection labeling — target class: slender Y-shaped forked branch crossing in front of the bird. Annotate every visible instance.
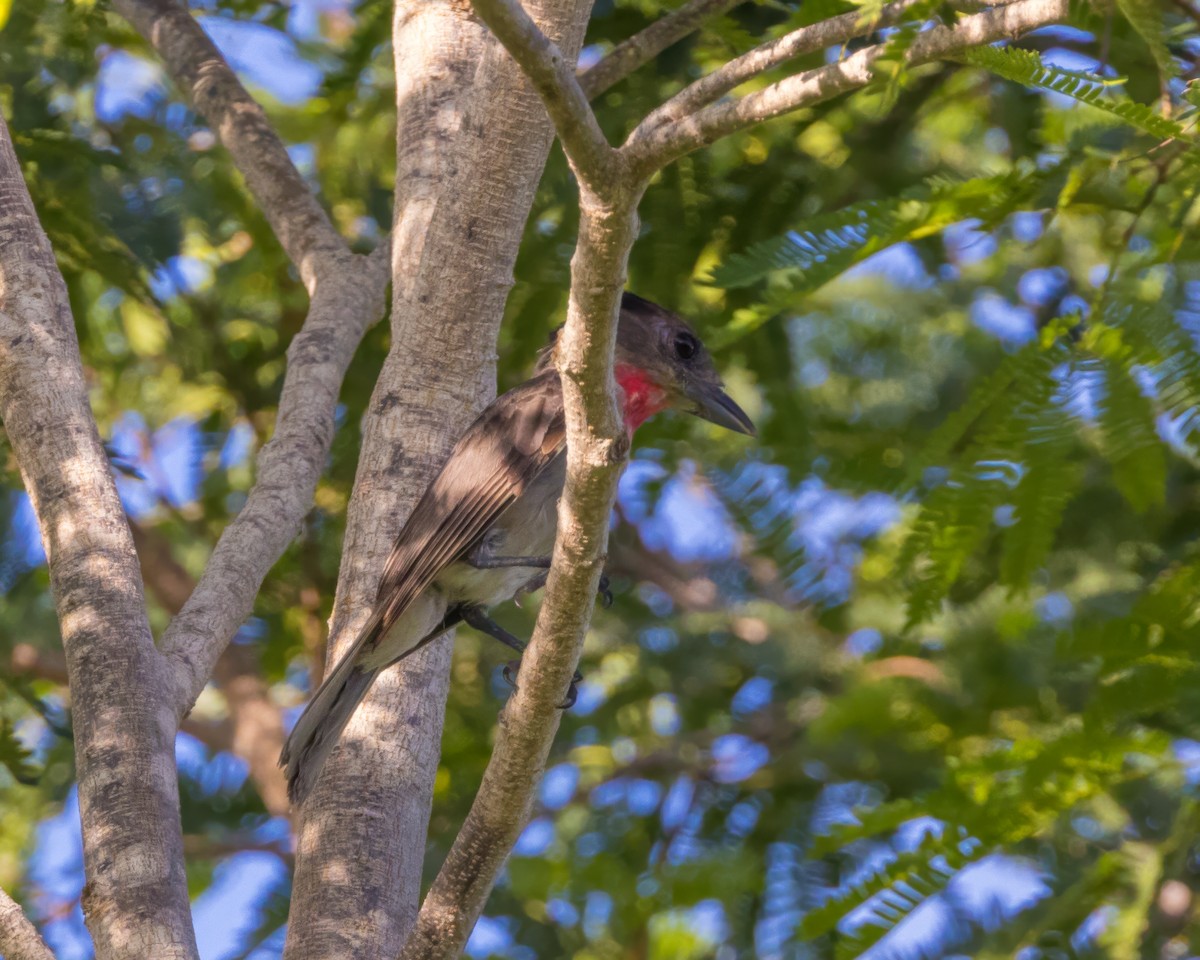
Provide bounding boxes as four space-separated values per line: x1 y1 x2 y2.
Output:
401 0 1068 960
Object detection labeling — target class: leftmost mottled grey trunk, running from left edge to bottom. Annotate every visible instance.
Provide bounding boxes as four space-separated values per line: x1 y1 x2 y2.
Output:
0 119 197 960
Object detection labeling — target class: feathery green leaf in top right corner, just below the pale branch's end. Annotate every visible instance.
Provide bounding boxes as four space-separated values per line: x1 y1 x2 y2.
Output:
964 47 1194 145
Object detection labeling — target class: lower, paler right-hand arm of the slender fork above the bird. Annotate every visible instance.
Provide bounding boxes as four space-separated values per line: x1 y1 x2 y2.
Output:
620 0 1068 175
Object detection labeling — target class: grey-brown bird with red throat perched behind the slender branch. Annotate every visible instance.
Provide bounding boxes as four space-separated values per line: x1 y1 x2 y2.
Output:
280 292 755 805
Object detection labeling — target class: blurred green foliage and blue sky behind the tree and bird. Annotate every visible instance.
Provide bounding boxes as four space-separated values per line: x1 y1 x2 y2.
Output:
0 0 1200 960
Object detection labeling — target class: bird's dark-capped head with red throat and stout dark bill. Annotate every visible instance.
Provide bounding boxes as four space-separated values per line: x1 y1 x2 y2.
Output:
539 292 755 437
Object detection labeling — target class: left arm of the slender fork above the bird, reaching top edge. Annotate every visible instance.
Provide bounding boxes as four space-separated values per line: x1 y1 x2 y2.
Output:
473 0 622 190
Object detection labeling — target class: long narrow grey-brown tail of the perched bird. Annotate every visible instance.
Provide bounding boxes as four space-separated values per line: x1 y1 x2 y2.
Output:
280 617 383 806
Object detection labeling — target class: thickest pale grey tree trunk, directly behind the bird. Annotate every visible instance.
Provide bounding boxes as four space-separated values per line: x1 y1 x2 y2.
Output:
286 0 600 960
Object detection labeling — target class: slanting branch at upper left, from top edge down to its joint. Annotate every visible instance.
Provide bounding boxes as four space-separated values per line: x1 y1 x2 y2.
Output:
113 0 347 286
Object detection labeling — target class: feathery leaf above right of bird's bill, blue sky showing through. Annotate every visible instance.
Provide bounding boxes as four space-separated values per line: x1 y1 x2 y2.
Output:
713 166 1046 294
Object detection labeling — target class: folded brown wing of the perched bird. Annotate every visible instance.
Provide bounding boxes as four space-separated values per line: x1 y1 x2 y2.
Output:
376 371 566 636
